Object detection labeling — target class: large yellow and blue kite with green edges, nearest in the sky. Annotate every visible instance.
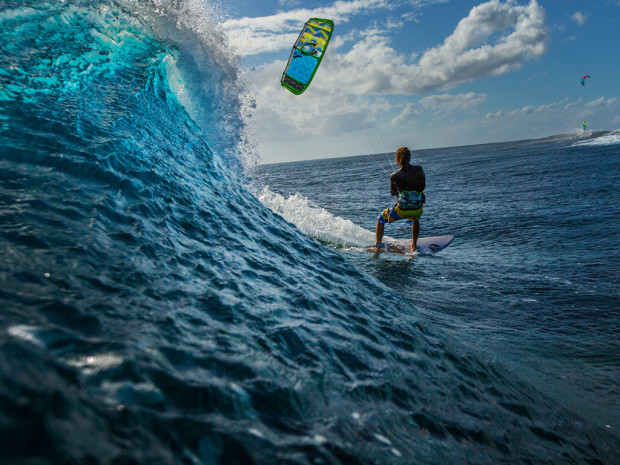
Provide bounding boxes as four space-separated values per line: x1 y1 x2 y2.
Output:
280 18 334 95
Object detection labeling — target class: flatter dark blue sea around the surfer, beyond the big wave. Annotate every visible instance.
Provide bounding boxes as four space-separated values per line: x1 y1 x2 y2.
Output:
259 132 620 435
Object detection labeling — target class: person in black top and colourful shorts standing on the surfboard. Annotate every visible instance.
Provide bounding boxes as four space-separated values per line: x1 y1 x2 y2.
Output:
375 147 426 252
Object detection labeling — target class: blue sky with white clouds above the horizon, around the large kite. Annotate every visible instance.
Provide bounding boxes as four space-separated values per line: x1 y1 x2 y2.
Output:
223 0 620 163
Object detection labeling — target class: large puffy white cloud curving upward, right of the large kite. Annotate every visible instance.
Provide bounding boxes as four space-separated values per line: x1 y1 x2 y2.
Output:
312 0 550 95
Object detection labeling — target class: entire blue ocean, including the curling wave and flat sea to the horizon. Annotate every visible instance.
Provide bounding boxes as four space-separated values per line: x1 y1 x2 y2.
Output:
0 0 620 465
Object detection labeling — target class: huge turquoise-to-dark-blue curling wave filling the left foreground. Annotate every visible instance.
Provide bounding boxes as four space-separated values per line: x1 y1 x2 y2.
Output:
0 0 618 465
